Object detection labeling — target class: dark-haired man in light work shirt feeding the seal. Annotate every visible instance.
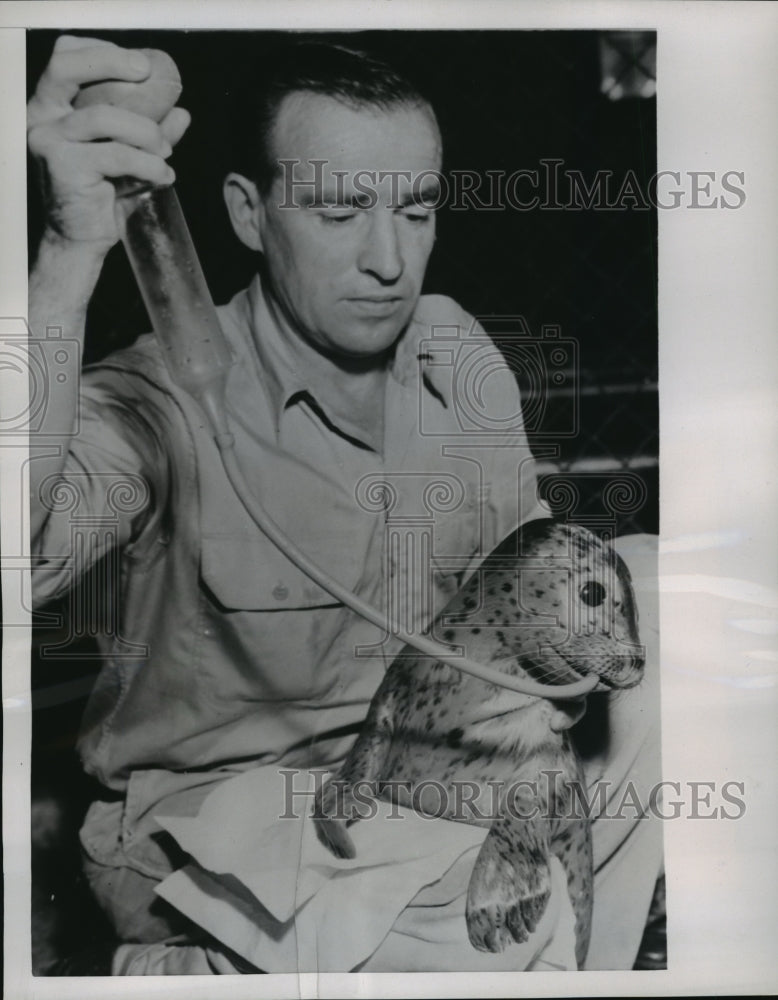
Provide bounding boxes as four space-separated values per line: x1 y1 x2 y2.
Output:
29 37 656 974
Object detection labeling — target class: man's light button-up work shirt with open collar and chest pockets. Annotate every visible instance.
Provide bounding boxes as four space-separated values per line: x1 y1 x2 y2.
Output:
33 279 546 809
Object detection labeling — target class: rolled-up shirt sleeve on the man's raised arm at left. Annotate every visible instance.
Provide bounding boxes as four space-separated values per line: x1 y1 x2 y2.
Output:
31 369 168 606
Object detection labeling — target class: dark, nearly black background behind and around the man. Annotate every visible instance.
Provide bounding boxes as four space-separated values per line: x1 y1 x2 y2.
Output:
27 31 658 972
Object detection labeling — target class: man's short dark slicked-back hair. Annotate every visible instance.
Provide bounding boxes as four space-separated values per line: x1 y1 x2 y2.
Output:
235 40 431 195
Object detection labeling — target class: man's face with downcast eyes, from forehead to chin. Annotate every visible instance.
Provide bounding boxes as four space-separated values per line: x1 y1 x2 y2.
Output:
253 92 441 360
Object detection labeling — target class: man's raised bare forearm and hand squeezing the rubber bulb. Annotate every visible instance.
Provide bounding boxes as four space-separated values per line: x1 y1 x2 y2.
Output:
28 35 189 545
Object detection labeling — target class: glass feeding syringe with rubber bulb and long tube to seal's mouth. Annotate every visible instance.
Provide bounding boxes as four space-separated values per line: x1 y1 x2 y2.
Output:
75 50 598 701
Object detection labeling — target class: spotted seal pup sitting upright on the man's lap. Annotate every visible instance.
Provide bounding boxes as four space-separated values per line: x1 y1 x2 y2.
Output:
314 519 644 966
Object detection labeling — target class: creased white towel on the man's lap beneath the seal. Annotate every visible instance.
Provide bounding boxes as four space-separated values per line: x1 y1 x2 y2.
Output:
157 767 575 972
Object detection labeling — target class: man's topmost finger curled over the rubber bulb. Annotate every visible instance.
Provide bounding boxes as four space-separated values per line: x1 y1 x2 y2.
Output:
35 42 151 107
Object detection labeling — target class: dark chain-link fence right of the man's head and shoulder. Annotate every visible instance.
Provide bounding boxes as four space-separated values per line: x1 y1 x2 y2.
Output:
407 32 659 534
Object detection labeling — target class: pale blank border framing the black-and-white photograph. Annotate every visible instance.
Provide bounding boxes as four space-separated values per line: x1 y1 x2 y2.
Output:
0 0 778 1000
